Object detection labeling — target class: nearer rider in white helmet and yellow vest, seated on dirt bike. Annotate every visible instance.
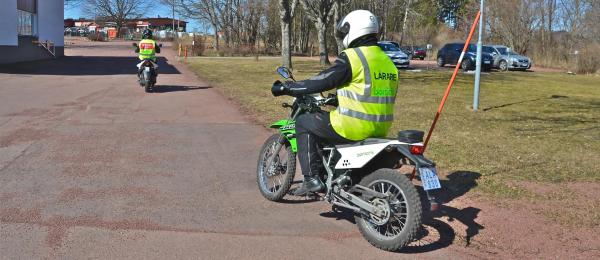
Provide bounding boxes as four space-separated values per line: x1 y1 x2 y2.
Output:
271 10 398 196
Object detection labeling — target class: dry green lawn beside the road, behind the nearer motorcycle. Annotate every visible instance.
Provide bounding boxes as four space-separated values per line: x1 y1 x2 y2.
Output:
189 58 600 197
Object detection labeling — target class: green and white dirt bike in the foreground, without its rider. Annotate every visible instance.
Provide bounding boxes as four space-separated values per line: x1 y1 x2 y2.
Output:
257 67 441 251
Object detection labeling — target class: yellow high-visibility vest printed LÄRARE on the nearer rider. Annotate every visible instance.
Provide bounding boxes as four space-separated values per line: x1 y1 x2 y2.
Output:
330 46 398 141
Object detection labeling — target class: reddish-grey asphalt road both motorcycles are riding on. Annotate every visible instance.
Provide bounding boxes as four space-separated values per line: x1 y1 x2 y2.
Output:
0 43 464 259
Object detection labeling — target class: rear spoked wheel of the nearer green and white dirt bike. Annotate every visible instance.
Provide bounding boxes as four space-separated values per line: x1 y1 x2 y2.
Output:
355 169 422 251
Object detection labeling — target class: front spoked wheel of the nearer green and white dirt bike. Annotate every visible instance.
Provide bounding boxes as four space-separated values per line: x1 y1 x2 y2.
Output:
256 134 296 201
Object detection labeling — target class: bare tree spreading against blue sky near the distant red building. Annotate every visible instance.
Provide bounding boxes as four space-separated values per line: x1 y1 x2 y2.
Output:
86 0 147 36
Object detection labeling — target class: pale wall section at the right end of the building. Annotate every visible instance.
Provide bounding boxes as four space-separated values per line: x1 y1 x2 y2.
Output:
37 0 65 47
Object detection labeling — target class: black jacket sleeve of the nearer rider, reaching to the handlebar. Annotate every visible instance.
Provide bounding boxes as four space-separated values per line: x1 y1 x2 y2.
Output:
287 53 352 95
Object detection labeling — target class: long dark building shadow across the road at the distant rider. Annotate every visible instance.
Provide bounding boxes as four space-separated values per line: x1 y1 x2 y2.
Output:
0 56 181 74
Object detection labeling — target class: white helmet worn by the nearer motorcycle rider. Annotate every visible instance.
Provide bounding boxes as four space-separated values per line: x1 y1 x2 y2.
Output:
335 10 379 48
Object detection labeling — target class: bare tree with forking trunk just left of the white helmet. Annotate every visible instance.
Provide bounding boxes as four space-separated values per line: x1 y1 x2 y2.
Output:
301 0 335 65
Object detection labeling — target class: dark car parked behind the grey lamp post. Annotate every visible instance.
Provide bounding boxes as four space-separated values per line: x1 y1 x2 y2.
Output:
437 43 494 71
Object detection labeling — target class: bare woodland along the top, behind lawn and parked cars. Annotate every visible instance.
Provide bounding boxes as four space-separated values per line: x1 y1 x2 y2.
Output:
66 0 600 73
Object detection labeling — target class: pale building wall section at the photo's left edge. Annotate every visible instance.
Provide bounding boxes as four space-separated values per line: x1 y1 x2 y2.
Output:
0 0 18 46
